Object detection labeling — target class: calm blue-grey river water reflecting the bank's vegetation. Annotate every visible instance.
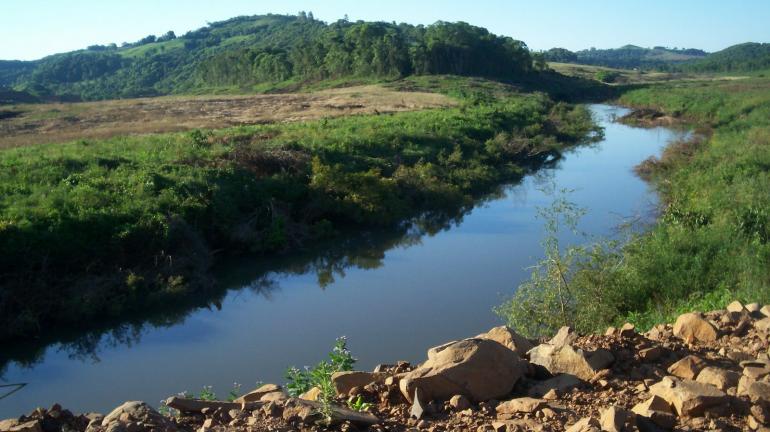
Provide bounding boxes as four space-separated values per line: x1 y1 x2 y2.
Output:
0 105 682 419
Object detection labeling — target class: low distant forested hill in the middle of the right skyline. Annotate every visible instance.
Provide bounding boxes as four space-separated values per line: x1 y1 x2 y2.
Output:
544 45 707 69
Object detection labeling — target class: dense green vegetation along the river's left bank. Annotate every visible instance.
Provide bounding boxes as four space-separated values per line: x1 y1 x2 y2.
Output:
0 77 594 338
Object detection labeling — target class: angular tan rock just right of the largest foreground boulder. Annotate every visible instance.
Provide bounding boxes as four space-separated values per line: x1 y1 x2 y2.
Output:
529 343 615 381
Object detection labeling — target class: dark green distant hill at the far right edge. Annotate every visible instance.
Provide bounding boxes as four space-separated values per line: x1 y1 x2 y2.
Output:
683 42 770 72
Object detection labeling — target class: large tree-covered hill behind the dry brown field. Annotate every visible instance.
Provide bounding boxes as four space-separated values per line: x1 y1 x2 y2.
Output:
0 13 533 100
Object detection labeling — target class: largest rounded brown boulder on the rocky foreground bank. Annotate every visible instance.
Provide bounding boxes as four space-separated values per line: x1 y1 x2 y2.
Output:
399 338 527 402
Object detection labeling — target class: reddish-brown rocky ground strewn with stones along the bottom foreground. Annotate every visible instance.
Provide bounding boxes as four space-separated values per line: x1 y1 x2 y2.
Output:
0 302 770 432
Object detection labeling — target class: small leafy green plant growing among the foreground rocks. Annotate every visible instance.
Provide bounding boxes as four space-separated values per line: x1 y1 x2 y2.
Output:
286 336 356 421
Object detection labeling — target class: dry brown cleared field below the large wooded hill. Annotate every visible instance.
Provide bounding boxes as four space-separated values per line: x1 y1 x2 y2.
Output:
0 85 456 148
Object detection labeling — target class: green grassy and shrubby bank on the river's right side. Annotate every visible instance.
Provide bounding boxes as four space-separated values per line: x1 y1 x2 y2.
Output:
498 73 770 334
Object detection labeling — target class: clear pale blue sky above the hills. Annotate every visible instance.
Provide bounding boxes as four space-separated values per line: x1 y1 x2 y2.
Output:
0 0 770 60
